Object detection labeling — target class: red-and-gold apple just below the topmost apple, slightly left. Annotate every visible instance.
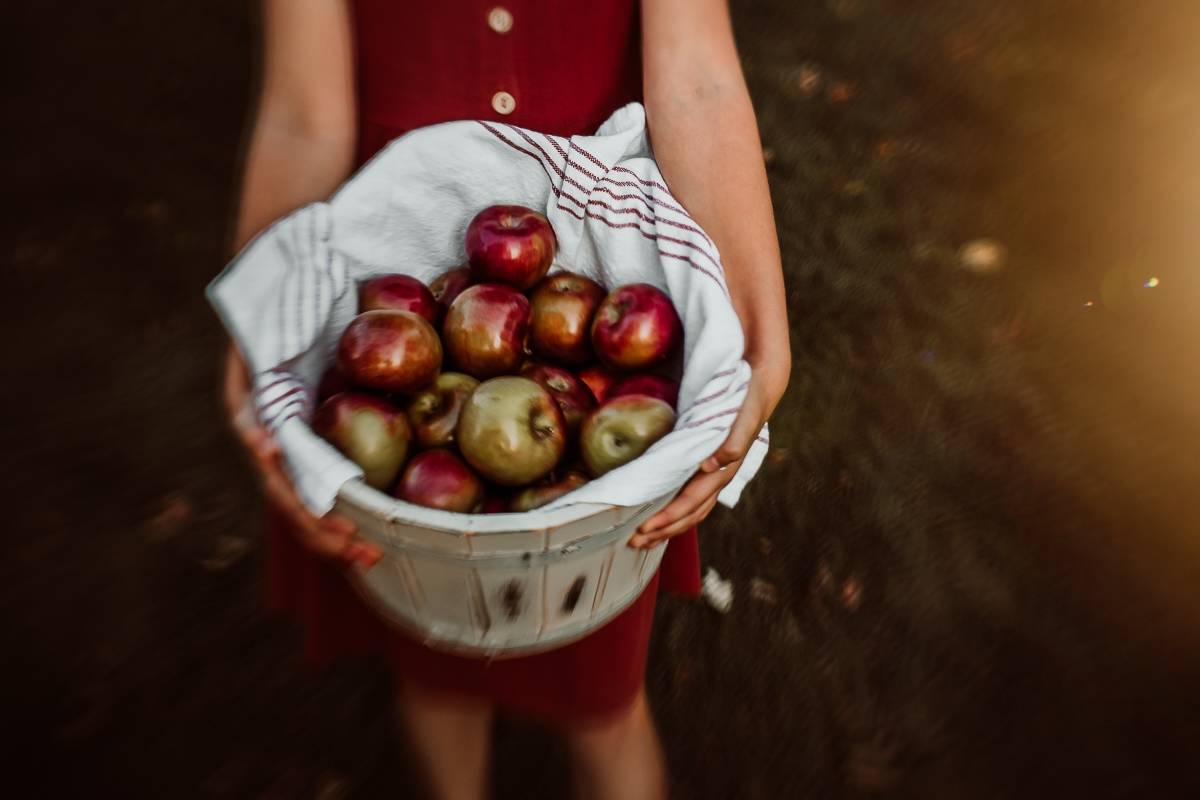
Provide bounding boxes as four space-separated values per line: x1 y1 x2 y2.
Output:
442 283 529 380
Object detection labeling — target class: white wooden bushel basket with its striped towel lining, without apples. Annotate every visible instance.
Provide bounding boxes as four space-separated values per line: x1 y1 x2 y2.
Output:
209 104 767 657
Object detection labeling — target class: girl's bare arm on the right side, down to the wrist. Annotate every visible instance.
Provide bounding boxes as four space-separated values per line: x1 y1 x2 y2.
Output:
643 4 791 383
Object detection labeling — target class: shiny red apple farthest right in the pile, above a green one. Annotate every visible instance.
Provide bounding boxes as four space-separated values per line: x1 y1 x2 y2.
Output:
592 283 683 372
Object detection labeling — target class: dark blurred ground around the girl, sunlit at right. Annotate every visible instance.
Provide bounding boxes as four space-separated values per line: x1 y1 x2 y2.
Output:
0 0 1200 800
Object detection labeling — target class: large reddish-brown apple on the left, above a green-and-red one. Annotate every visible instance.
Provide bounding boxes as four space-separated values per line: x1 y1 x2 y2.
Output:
337 311 442 392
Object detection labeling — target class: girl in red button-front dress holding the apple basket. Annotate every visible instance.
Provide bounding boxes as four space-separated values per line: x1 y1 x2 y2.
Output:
226 0 791 800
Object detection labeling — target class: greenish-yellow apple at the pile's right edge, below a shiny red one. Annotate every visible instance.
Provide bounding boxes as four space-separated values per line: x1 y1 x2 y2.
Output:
580 395 674 477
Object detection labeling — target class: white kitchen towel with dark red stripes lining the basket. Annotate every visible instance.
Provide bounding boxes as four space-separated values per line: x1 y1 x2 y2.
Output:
208 103 768 513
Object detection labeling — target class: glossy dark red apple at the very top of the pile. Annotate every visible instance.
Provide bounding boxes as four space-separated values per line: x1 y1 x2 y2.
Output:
467 205 558 291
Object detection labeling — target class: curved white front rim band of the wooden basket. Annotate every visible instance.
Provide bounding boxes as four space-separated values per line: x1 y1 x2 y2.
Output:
337 479 624 536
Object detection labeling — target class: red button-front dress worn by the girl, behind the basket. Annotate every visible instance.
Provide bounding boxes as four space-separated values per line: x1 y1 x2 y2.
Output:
268 0 700 722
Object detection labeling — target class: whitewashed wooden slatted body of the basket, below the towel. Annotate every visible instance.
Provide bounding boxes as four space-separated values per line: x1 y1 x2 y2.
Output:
337 482 673 658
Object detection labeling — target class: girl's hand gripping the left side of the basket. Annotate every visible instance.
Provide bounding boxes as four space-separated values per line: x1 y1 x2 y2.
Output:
224 345 383 569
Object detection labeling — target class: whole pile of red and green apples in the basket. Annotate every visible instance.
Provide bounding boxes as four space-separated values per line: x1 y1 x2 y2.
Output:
312 205 683 513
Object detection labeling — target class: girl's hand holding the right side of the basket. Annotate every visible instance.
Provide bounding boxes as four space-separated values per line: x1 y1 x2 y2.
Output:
629 363 788 548
